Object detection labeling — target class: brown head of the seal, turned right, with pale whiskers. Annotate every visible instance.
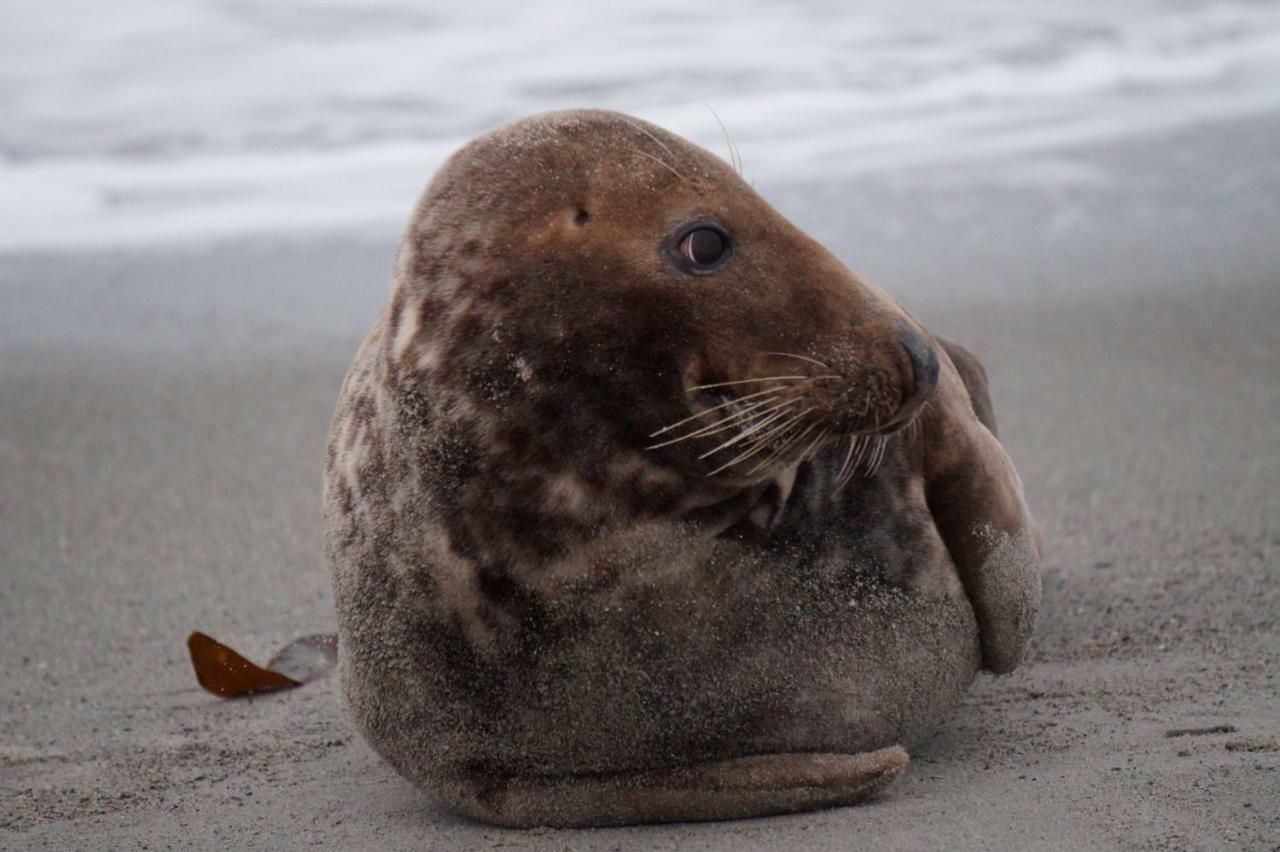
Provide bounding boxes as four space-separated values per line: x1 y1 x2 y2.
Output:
387 111 938 501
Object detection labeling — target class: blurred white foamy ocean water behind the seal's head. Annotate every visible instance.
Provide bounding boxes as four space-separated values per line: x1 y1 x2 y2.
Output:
0 0 1280 252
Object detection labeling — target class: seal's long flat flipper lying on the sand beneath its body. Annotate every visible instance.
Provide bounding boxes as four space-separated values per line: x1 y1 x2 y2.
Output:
445 746 908 828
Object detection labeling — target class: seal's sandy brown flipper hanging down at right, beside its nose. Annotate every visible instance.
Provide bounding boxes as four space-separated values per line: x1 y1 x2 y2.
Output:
924 344 1041 674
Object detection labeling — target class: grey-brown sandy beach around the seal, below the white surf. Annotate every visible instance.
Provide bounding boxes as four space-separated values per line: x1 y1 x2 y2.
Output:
0 116 1280 849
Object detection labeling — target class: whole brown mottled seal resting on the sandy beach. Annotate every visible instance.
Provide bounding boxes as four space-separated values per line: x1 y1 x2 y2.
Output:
325 111 1039 825
